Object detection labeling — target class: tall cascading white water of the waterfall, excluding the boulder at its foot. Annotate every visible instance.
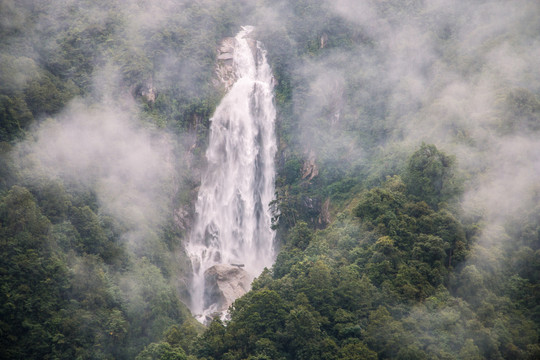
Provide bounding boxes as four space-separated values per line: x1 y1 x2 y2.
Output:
187 26 276 319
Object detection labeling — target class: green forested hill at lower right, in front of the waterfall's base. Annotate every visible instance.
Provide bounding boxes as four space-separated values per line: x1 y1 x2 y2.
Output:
197 145 540 359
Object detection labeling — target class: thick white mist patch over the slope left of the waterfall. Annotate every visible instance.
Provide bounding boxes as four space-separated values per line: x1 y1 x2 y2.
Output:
18 100 174 248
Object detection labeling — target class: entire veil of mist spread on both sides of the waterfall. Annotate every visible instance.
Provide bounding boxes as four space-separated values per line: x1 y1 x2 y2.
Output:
0 0 540 358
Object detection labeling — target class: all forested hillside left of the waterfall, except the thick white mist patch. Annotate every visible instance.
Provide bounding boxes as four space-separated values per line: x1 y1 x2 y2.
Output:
0 1 235 359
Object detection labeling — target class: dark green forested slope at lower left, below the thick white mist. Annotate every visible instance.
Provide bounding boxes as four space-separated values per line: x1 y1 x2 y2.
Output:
0 185 202 359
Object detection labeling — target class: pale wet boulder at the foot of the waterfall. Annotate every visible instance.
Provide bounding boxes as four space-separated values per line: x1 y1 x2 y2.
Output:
196 264 253 324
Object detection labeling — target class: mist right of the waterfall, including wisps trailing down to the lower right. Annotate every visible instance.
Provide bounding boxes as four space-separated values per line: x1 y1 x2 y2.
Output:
244 0 540 358
